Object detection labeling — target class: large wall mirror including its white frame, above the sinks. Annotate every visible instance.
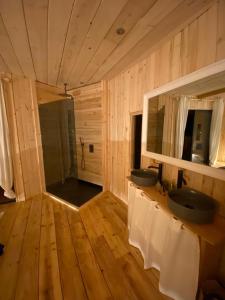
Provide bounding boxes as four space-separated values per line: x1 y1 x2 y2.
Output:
142 61 225 179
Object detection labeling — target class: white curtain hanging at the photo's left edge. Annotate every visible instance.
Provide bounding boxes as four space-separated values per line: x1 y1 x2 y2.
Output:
0 81 15 199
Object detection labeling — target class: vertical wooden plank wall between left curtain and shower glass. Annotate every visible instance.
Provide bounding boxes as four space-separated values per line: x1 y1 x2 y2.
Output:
4 77 45 201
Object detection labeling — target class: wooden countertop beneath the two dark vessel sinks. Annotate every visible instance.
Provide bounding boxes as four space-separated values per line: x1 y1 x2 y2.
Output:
128 178 225 246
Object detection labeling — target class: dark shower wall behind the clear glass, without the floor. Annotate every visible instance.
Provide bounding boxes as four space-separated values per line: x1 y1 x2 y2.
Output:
39 100 76 186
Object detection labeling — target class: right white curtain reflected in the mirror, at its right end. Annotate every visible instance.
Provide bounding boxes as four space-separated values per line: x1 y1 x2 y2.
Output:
209 98 224 166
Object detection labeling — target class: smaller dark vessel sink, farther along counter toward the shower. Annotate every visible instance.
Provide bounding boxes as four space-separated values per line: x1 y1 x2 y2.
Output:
131 169 158 186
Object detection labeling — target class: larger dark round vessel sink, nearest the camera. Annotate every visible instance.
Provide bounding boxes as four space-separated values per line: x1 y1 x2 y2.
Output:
168 188 217 224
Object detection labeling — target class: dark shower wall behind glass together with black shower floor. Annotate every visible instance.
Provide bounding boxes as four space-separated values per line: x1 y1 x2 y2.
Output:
39 99 101 206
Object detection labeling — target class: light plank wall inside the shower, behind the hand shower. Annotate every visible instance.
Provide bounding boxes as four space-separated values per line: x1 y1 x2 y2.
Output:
70 82 104 185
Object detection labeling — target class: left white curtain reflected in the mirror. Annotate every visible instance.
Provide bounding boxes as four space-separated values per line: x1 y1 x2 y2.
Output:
175 96 189 159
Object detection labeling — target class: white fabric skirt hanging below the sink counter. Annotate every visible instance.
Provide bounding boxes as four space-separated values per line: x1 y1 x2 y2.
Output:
128 182 200 300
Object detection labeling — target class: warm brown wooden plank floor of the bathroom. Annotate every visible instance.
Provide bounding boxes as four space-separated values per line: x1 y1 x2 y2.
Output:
0 192 168 300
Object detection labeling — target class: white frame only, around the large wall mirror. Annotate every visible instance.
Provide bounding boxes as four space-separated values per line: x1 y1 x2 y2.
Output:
141 59 225 181
